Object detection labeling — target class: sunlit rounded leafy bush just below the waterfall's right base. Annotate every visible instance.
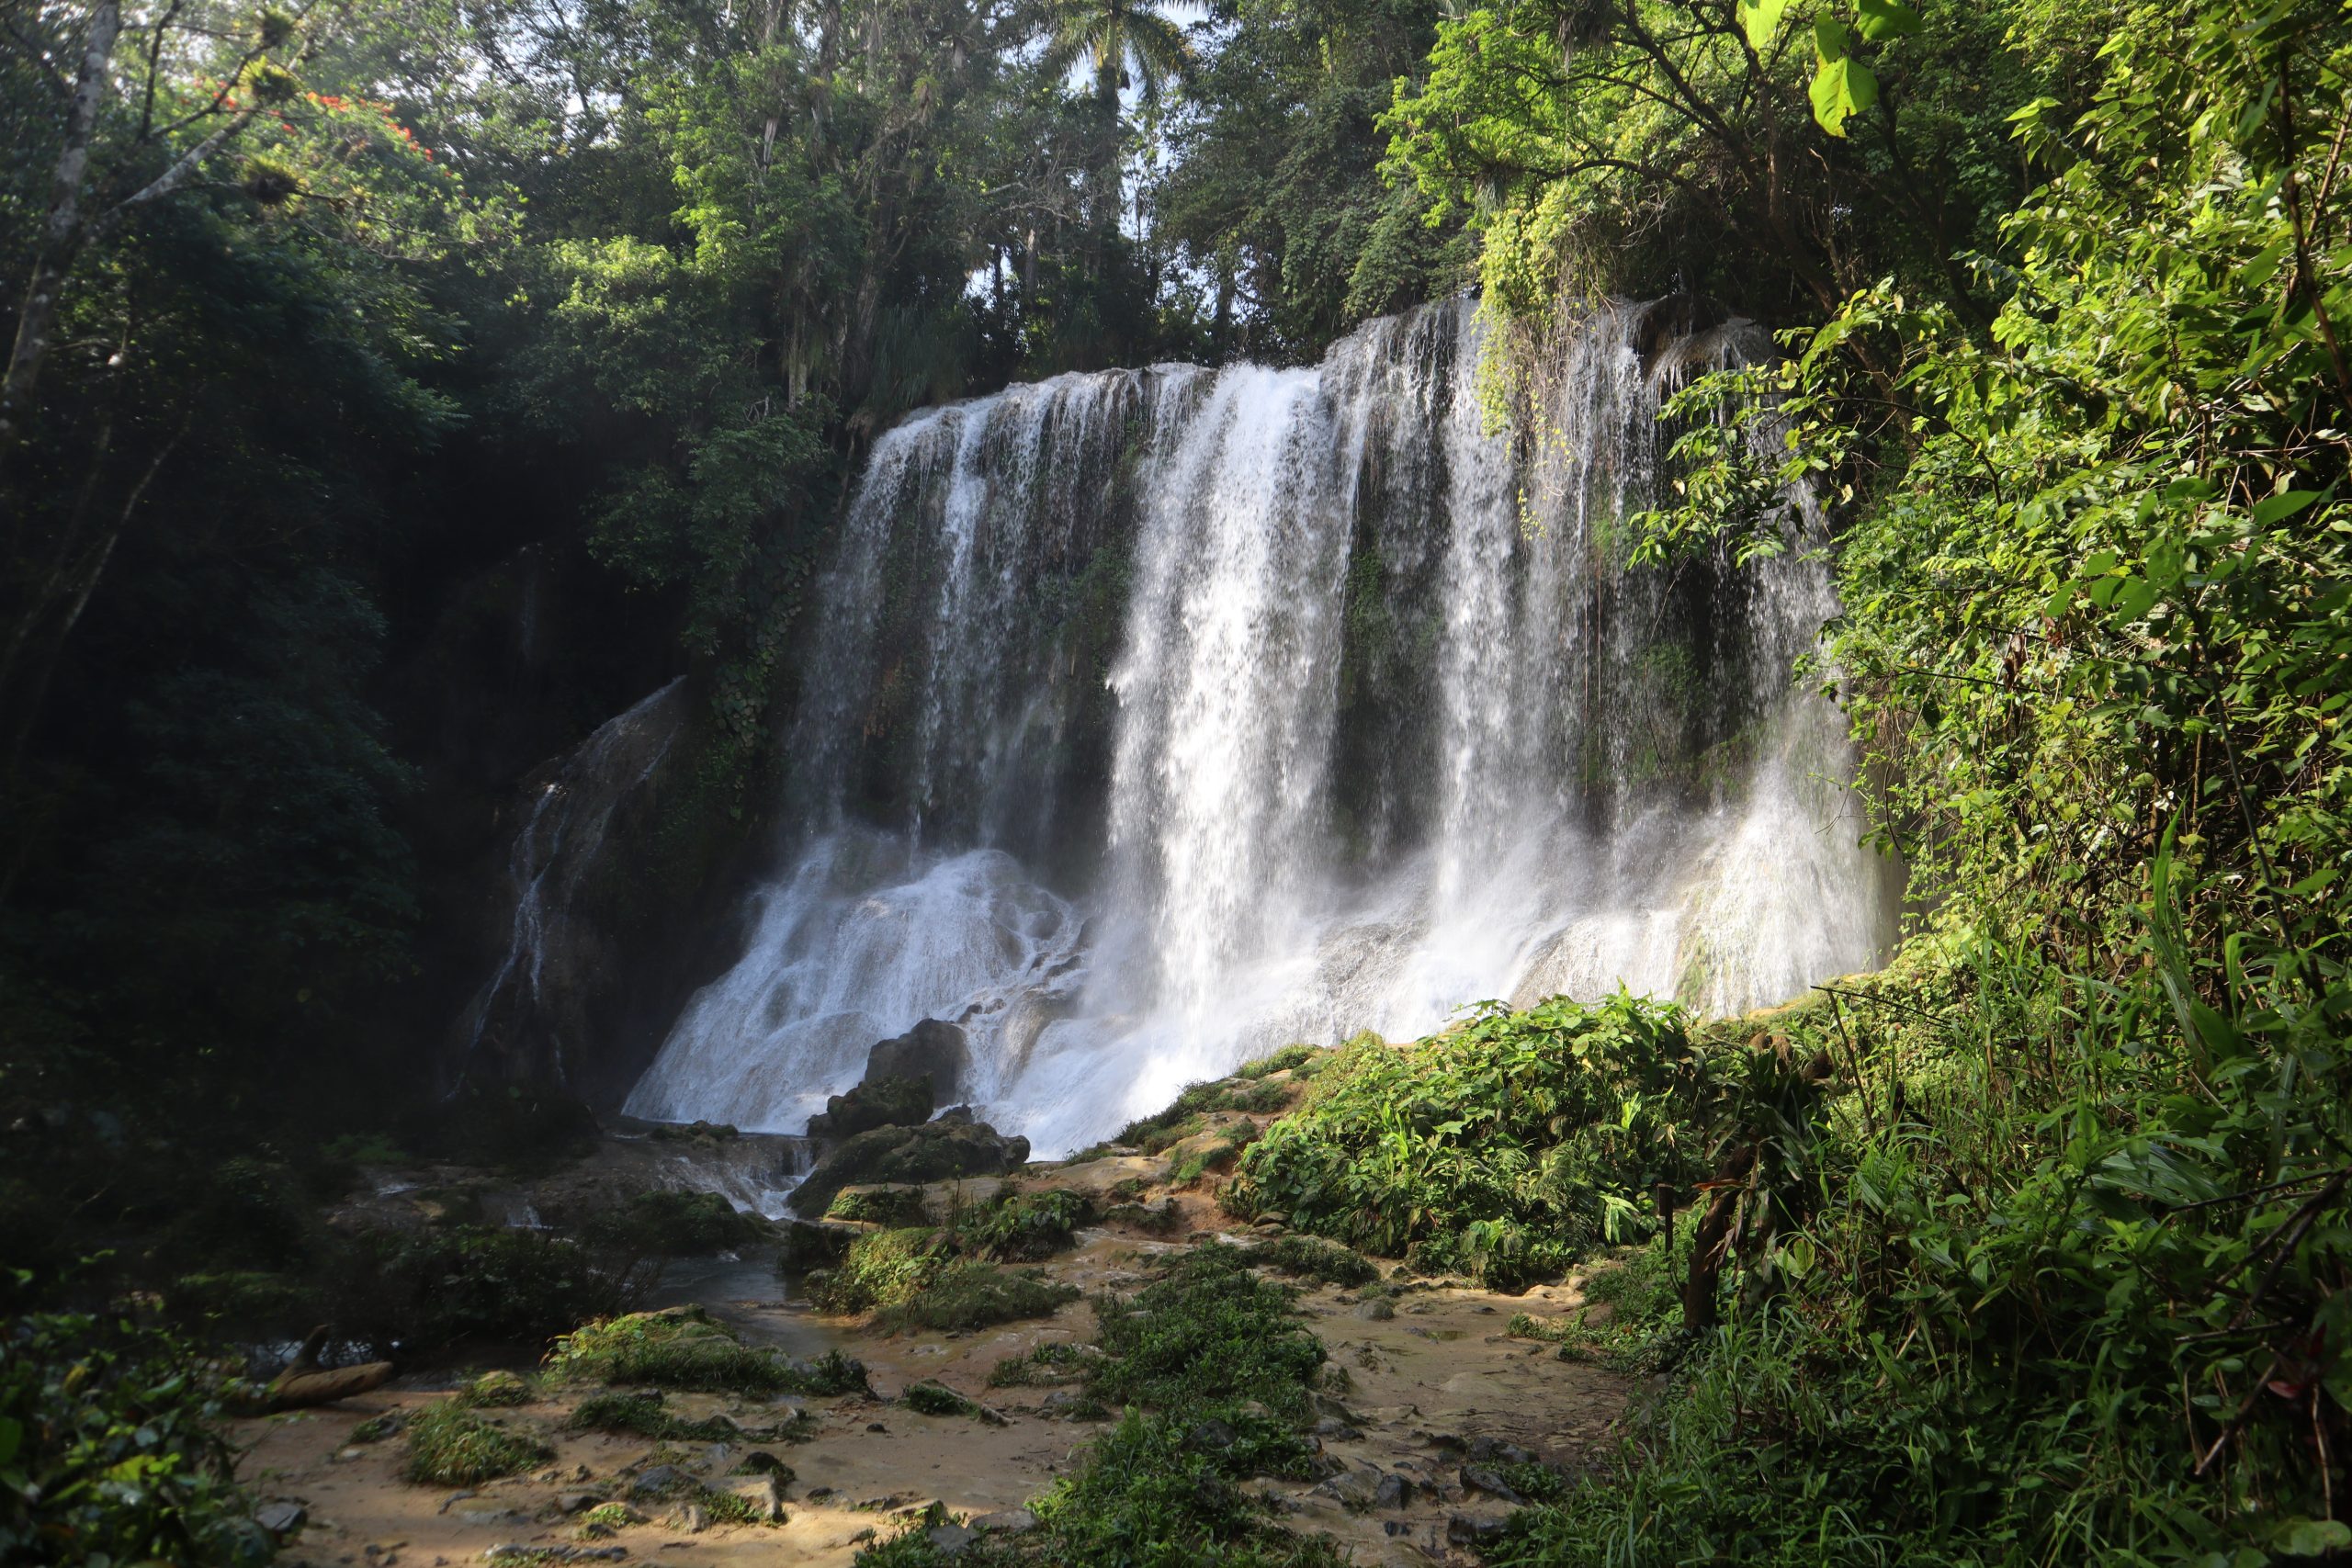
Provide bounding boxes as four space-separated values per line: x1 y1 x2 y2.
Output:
1223 995 1710 1288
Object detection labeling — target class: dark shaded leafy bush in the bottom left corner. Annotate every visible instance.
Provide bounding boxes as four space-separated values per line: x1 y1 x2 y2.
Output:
0 1314 273 1568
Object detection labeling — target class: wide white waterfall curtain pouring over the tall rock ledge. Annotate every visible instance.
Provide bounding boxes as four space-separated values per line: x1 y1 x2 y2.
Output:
628 301 1884 1155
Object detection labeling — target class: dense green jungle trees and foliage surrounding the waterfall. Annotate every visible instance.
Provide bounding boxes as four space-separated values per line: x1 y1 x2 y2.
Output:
0 0 2352 1568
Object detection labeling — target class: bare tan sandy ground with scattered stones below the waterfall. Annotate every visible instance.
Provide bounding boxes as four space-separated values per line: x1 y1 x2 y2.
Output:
238 1133 1630 1568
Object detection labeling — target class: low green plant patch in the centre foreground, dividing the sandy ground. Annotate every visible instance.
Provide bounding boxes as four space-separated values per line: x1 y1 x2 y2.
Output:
858 1246 1348 1568
